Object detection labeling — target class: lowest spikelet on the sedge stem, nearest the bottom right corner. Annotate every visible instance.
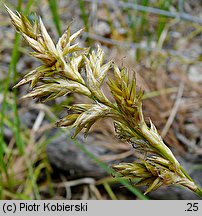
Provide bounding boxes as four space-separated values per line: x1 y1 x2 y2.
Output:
113 156 197 194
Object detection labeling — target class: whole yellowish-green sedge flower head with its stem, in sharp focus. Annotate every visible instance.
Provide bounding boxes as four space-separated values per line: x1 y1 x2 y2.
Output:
6 7 202 196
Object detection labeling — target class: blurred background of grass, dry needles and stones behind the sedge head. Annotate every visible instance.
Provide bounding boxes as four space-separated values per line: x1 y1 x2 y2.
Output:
0 0 202 200
